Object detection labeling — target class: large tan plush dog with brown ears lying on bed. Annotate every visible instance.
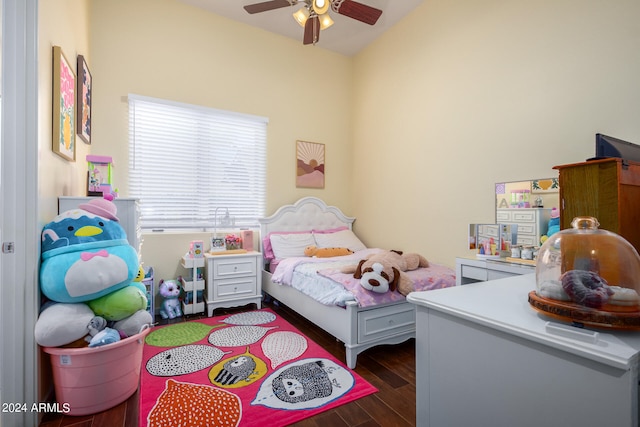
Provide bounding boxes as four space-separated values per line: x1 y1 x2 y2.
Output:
342 250 429 296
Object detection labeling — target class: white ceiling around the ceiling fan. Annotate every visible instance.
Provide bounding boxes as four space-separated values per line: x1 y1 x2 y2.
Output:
179 0 423 56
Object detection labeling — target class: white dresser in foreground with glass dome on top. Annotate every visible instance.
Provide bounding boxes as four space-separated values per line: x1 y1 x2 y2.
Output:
407 274 640 427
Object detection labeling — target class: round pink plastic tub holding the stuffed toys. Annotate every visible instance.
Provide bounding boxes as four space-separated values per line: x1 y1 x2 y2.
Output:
43 328 150 415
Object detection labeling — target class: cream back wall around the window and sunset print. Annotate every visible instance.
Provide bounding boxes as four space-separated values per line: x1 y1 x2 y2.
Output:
89 0 353 286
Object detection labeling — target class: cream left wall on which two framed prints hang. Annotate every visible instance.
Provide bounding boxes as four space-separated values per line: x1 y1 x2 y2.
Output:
38 0 91 225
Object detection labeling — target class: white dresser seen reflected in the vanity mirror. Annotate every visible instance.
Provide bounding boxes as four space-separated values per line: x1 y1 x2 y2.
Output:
496 208 551 246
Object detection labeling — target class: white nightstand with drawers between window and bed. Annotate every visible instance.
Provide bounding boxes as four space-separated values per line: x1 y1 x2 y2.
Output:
205 252 262 317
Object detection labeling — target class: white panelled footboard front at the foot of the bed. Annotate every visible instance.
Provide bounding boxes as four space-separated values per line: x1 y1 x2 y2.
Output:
358 304 416 343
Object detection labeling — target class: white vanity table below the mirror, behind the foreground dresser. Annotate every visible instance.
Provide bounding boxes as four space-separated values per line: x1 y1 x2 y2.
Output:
456 257 536 286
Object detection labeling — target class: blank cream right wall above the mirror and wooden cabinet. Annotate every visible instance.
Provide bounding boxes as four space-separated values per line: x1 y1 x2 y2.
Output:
351 0 640 266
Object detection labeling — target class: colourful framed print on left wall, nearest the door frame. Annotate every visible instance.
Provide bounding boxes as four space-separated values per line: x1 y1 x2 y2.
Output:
52 46 76 162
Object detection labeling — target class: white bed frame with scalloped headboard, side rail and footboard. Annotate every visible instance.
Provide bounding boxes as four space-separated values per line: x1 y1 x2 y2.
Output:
260 197 415 369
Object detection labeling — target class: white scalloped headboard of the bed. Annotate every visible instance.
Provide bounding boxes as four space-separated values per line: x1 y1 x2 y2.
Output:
260 197 356 254
